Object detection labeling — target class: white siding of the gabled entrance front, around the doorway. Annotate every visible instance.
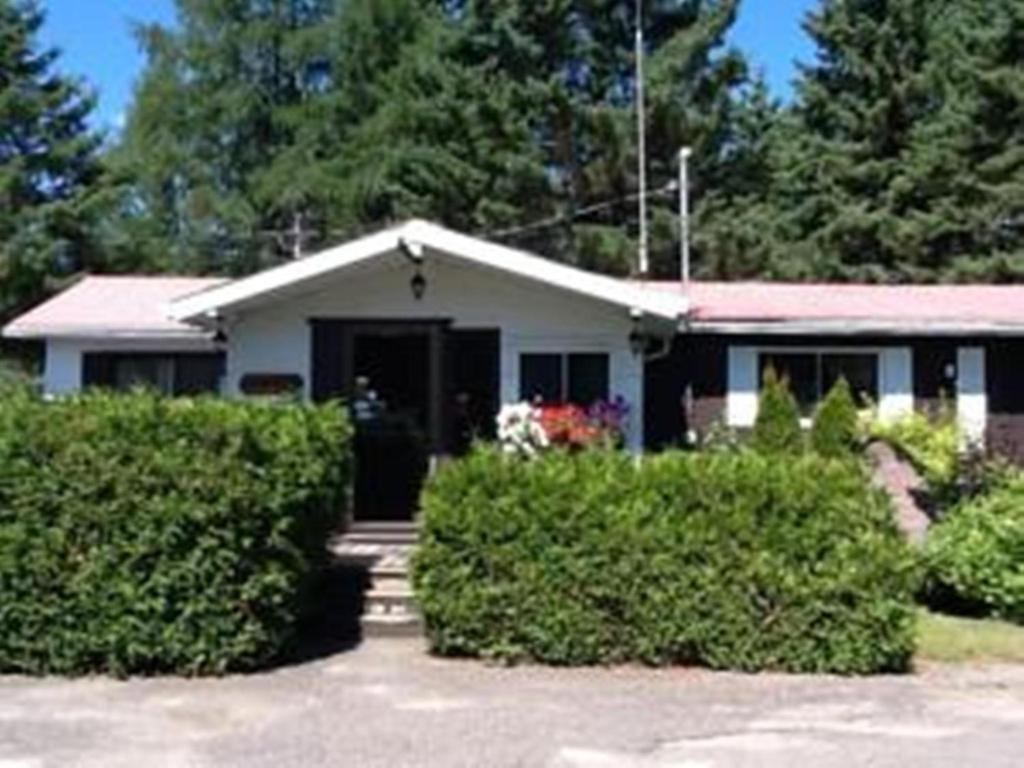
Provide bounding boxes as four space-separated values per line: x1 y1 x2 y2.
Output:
225 254 643 449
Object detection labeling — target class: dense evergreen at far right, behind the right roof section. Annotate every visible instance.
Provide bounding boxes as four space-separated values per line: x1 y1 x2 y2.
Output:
734 0 1024 282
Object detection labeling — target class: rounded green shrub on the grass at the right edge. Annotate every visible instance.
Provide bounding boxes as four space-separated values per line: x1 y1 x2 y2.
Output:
925 480 1024 624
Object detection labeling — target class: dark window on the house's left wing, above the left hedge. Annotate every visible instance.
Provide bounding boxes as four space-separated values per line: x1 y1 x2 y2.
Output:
82 352 224 396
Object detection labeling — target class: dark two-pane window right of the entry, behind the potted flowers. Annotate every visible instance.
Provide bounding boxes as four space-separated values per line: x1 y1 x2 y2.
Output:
519 352 610 406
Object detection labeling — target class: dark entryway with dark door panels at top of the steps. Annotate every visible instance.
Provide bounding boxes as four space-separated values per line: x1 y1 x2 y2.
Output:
311 319 500 521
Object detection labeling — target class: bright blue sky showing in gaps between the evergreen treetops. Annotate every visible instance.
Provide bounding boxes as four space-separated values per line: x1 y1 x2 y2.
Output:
43 0 815 131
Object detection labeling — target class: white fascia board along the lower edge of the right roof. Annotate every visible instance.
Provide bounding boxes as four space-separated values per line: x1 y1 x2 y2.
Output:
681 319 1024 337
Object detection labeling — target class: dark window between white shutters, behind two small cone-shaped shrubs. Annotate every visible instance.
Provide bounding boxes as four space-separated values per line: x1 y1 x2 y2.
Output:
759 350 879 416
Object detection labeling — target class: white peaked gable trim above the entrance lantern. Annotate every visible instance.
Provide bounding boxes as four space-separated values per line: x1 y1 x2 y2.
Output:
169 220 688 322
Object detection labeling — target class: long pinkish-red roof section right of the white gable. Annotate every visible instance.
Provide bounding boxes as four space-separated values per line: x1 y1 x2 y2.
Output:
647 282 1024 334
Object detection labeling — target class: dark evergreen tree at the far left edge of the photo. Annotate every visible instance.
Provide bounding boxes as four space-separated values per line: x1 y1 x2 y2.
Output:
0 0 100 319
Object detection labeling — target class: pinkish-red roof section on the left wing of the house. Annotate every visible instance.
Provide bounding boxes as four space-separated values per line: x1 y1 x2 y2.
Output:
3 275 224 339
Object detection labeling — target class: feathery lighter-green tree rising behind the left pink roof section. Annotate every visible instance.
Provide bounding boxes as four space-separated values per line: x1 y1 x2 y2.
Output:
112 0 333 273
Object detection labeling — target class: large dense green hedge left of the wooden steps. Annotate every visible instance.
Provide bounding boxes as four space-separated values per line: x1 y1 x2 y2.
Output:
0 393 350 675
